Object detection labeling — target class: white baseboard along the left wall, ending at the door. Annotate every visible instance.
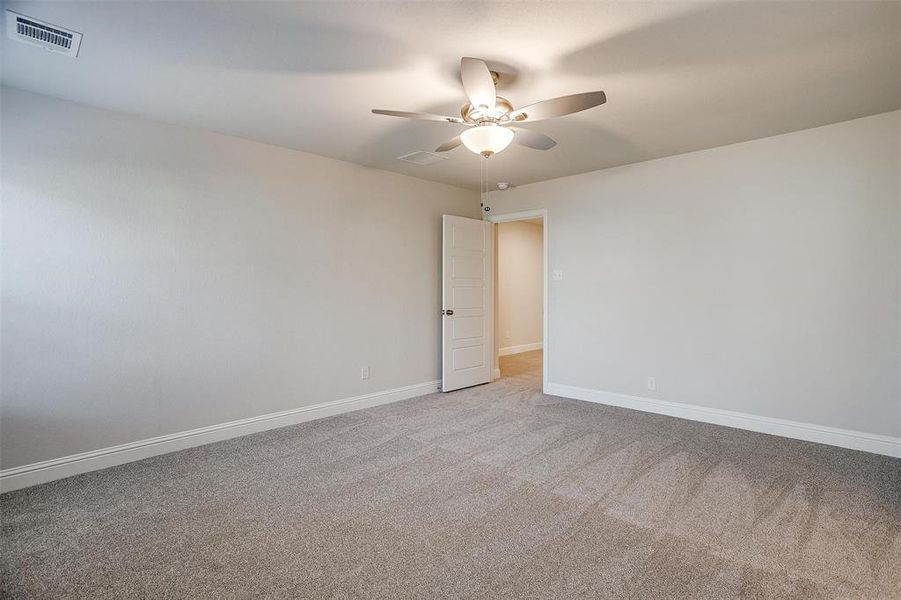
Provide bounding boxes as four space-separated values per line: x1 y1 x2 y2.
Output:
0 381 440 493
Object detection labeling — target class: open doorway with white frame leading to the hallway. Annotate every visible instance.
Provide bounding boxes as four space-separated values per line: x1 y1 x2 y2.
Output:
490 210 547 389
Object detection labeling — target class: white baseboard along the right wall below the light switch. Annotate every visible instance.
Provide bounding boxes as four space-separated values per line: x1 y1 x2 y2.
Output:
545 383 901 458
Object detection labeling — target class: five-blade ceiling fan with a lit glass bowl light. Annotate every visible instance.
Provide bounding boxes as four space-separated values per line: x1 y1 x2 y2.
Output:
372 58 607 158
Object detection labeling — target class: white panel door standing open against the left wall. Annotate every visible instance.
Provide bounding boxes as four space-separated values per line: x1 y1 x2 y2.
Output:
441 215 494 392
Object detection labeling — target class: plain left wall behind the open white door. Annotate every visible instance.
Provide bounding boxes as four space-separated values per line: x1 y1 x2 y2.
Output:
0 88 479 468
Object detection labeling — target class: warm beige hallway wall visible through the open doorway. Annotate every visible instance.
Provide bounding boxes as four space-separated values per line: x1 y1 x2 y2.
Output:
497 221 544 353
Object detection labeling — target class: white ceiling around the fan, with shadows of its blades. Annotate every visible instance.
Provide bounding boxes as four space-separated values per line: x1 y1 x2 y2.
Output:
2 2 901 189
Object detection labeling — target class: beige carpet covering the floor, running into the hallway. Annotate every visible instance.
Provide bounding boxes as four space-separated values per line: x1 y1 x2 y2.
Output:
0 353 901 598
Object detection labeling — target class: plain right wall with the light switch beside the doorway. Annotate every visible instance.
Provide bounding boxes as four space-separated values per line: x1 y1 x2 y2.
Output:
490 112 901 436
